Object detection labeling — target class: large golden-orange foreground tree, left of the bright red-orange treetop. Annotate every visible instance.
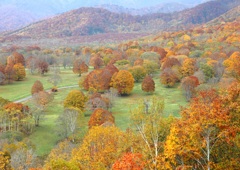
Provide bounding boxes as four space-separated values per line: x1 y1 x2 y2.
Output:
71 126 126 169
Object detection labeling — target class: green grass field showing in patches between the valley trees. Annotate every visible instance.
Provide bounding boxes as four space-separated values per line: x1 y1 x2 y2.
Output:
0 69 187 156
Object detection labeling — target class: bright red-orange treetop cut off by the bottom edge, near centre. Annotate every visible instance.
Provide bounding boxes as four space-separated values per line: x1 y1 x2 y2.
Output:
112 153 145 170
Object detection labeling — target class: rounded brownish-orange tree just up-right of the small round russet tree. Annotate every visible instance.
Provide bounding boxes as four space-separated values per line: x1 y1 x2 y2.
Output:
160 68 178 87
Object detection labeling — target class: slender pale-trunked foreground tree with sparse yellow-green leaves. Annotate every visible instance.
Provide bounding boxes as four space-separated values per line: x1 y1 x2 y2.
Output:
131 97 171 169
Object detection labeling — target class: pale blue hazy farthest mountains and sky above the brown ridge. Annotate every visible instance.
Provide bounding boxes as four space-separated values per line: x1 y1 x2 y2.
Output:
0 0 208 32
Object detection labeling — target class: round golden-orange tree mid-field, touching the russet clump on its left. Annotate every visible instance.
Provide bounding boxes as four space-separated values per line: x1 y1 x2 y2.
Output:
111 70 134 95
